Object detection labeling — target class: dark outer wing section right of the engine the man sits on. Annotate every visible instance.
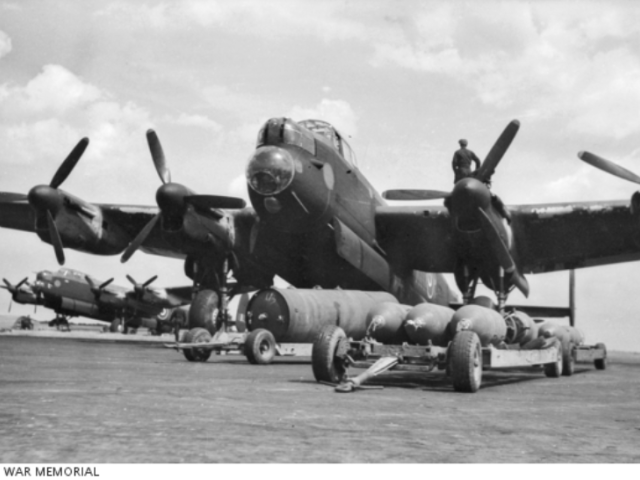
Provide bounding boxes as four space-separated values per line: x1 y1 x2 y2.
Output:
509 201 640 273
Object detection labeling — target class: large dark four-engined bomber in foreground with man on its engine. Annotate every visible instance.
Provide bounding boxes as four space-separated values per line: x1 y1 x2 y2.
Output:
0 118 640 338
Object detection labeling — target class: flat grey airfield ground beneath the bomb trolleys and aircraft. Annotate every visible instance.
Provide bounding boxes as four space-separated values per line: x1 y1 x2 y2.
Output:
0 332 640 463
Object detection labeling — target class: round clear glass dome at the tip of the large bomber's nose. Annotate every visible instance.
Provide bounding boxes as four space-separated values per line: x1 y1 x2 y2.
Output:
246 146 295 195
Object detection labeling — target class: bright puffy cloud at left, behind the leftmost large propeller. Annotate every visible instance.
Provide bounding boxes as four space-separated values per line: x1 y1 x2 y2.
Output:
0 65 151 190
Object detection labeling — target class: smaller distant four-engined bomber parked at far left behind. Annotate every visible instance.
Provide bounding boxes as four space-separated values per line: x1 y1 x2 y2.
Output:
2 268 191 335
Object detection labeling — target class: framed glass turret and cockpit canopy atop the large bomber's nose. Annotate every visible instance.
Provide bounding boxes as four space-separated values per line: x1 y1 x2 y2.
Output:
256 118 357 166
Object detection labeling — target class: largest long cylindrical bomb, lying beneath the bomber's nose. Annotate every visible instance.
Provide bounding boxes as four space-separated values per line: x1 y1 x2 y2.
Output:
247 288 397 343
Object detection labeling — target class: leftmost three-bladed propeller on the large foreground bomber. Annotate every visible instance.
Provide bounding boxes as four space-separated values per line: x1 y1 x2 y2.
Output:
27 137 89 265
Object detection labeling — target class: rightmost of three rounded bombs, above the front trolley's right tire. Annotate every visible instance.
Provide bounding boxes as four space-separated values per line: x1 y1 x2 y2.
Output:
447 305 507 347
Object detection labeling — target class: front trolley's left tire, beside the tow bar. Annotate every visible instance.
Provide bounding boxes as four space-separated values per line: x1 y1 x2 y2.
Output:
311 325 347 384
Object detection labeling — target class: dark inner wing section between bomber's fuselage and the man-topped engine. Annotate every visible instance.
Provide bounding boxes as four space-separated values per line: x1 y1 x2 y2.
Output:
376 206 456 272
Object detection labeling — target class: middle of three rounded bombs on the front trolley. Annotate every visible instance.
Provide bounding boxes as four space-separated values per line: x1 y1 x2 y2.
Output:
404 303 455 346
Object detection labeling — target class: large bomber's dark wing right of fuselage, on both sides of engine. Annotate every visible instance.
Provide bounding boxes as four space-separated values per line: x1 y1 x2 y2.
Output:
376 201 640 273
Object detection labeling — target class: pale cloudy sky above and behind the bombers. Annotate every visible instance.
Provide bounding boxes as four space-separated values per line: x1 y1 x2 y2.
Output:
0 0 640 351
